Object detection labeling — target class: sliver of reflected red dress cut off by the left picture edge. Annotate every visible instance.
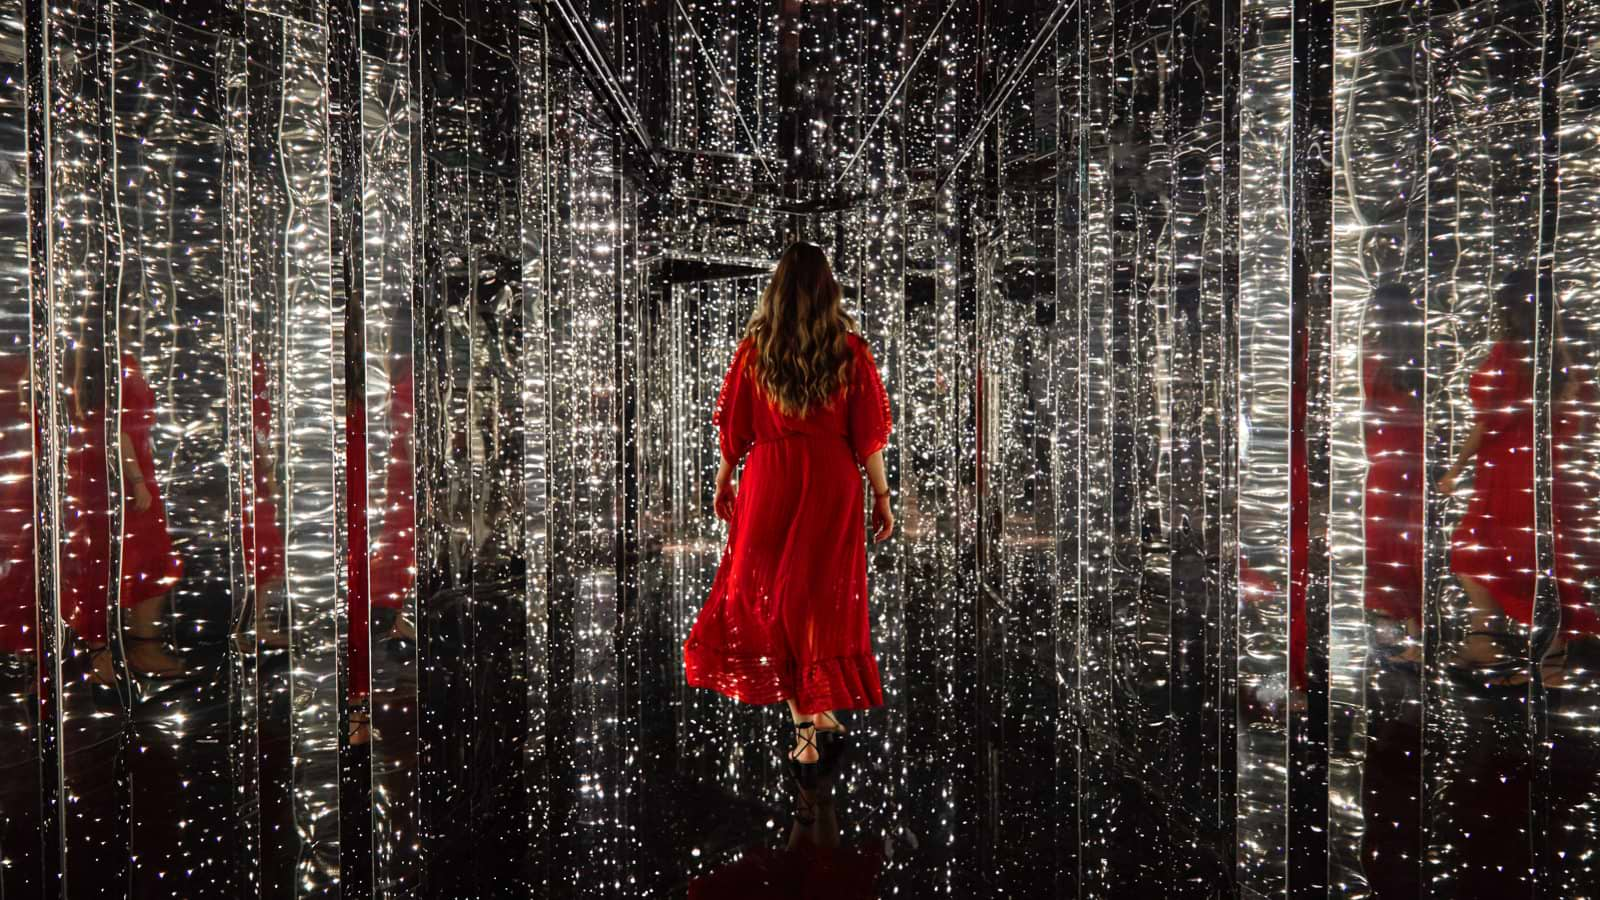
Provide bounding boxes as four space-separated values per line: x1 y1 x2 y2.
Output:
0 356 38 653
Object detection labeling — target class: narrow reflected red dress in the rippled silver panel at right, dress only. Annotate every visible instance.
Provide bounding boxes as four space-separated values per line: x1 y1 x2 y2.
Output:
1362 357 1422 621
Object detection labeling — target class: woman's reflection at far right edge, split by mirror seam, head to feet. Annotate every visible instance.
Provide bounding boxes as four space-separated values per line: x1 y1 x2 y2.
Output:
1438 272 1600 687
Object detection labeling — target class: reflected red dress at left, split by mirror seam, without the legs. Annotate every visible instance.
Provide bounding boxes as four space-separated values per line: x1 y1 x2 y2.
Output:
61 356 184 644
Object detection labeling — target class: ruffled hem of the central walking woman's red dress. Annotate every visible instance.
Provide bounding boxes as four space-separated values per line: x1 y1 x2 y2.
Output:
683 644 883 713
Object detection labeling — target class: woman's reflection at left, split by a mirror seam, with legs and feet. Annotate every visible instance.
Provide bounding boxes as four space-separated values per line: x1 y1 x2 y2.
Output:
61 344 184 687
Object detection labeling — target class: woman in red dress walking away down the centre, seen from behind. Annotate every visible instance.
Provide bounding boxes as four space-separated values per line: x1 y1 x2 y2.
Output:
683 243 894 783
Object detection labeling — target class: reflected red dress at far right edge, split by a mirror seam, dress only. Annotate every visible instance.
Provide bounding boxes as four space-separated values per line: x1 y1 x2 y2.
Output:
1450 341 1600 634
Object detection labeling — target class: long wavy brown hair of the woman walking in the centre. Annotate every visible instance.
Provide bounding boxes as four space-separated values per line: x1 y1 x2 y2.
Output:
744 243 856 416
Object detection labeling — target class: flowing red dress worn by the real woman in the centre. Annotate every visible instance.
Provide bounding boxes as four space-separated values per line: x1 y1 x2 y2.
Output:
683 335 893 713
